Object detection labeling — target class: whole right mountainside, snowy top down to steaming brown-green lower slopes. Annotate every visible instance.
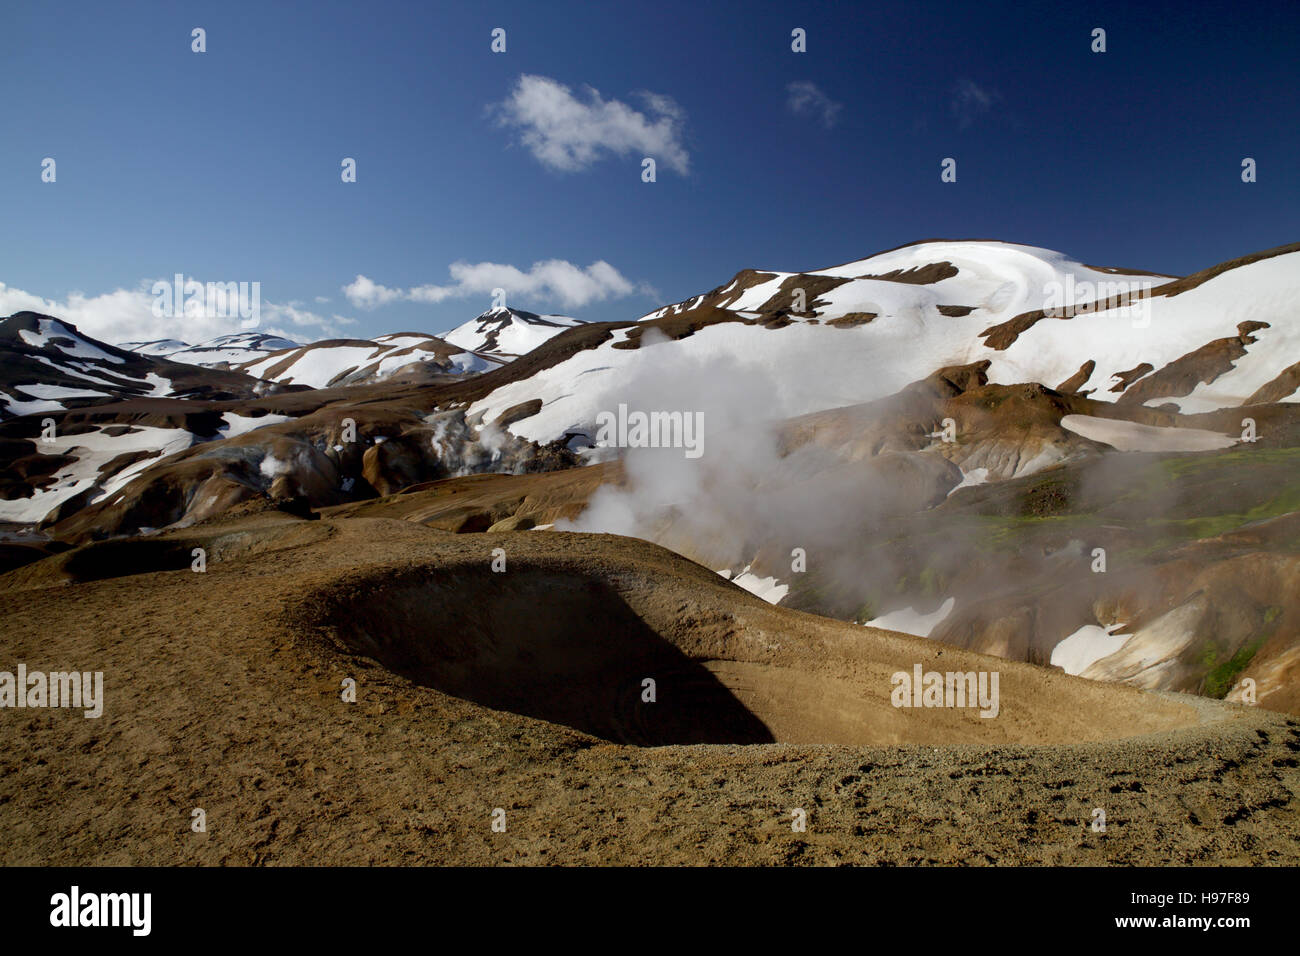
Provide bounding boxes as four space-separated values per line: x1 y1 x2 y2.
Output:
441 241 1300 710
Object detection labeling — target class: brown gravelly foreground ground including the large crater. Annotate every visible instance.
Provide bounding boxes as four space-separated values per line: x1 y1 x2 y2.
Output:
0 512 1300 865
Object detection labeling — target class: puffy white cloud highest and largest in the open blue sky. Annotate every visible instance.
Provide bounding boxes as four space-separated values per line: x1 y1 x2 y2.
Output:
493 74 690 176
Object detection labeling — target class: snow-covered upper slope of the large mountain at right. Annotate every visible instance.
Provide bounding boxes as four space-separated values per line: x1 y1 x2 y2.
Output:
473 241 1300 441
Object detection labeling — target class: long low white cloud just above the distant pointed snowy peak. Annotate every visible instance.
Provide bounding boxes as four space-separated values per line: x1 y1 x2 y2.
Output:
343 259 651 308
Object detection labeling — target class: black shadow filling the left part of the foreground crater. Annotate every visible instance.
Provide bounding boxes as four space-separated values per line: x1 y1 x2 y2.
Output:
325 566 774 747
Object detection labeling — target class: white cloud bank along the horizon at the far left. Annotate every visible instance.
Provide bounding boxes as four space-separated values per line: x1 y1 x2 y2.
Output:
0 276 345 345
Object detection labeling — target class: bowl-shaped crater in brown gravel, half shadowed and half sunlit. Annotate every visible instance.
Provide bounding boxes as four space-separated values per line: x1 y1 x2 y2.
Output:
258 520 1199 745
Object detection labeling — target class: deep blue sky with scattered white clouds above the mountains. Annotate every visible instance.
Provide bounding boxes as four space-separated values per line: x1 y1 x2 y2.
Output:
0 0 1300 341
